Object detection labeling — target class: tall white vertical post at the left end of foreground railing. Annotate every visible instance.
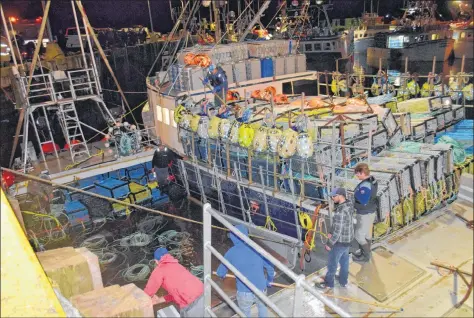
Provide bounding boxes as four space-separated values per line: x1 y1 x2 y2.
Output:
202 203 212 317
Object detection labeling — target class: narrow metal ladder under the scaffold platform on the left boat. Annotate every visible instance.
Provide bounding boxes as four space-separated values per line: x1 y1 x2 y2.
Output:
58 102 90 162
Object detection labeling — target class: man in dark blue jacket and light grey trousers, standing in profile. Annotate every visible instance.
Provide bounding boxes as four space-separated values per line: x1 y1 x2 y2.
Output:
353 163 378 263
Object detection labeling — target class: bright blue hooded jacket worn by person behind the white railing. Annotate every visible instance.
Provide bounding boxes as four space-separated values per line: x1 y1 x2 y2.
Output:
217 224 275 293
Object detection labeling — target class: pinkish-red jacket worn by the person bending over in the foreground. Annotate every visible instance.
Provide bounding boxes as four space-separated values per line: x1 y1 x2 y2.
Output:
145 254 204 309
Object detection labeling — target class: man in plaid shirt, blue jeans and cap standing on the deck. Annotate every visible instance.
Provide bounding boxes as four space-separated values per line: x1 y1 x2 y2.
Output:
316 188 354 289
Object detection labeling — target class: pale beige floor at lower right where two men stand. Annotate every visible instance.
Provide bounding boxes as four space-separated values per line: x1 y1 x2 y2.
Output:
260 198 474 317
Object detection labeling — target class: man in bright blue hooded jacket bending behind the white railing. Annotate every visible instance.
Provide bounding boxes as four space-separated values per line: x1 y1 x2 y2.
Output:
217 224 275 317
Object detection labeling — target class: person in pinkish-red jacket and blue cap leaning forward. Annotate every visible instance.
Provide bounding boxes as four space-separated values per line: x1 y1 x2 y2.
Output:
145 247 204 317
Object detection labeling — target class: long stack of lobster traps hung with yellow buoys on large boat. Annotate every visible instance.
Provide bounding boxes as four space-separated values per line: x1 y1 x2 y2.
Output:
172 90 459 243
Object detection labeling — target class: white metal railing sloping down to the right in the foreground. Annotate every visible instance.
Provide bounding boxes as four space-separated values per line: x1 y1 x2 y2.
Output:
203 203 351 317
